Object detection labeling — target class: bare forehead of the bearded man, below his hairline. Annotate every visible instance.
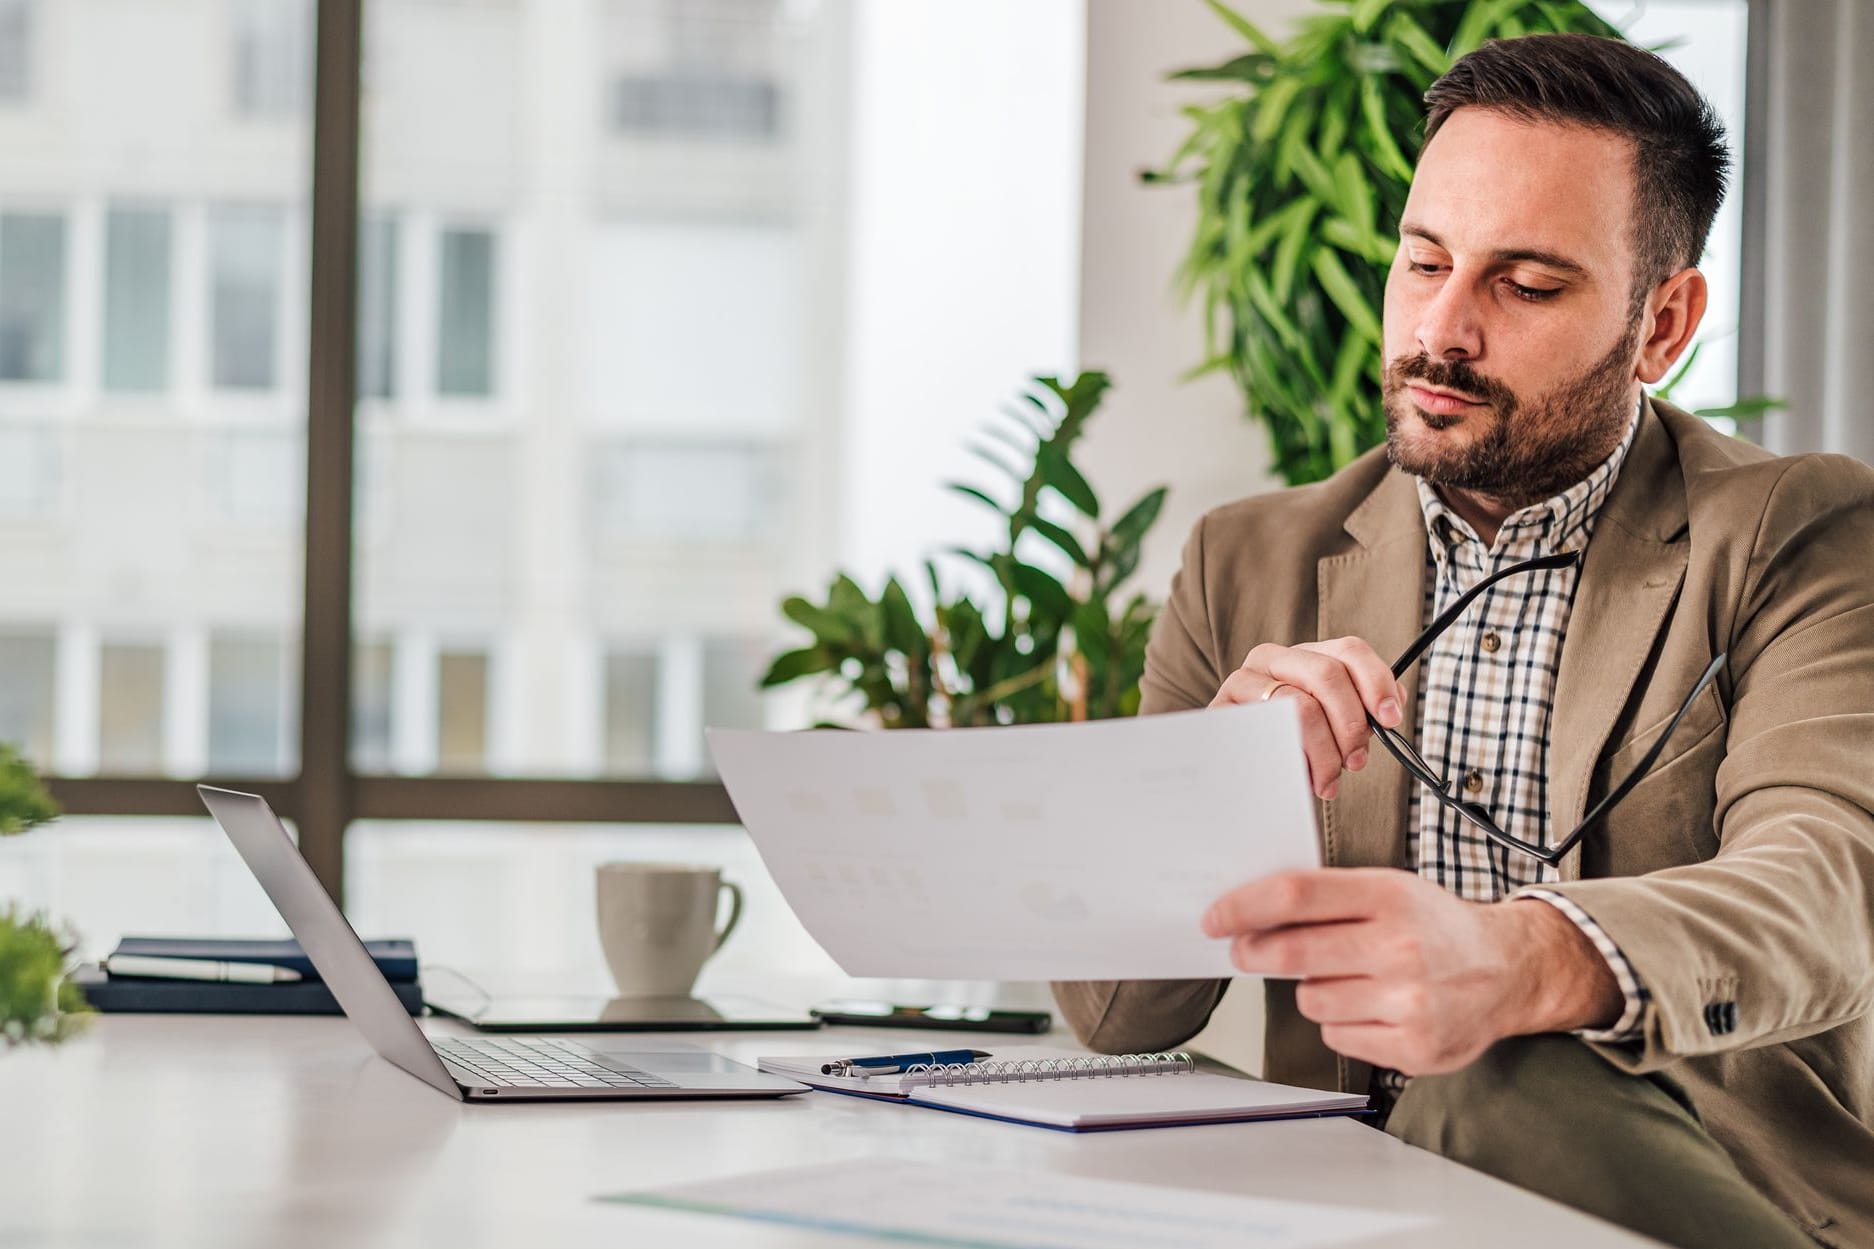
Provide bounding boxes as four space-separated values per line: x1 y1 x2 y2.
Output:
1400 107 1634 272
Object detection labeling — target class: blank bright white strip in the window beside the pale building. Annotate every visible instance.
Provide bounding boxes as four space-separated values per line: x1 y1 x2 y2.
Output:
838 0 1086 587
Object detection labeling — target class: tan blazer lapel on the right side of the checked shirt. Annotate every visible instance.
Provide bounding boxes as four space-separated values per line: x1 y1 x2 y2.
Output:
1548 399 1688 880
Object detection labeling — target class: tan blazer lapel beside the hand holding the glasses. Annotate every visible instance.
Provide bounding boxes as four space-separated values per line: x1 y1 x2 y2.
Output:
1316 469 1426 866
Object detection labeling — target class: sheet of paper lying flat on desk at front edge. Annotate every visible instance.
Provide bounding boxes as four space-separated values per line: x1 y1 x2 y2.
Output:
600 1159 1428 1249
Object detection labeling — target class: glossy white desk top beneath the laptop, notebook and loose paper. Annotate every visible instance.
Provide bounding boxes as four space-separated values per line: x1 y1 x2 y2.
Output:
0 1015 1653 1249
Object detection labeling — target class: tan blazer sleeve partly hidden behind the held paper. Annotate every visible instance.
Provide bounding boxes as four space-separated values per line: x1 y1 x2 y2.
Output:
1053 519 1229 1054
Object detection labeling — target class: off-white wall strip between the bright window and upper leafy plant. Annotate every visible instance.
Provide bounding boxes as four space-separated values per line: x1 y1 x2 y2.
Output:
1079 0 1316 1069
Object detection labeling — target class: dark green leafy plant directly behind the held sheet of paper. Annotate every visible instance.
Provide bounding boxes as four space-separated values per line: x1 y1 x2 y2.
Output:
761 373 1166 728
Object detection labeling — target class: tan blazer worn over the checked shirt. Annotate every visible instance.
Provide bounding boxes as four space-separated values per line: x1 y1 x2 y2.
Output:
1055 401 1874 1245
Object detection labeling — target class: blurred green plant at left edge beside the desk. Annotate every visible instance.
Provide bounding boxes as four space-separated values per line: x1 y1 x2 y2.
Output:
0 743 90 1048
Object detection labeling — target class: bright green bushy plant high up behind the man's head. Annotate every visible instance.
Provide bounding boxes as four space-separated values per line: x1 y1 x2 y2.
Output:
1145 0 1619 484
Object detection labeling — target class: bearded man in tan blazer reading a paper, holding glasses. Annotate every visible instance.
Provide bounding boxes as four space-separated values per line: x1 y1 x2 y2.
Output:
1055 36 1874 1249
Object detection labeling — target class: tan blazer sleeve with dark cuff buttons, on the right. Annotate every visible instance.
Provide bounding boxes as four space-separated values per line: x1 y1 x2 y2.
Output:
1544 456 1874 1073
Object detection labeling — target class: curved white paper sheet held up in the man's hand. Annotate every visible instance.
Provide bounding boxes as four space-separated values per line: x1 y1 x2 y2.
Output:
708 700 1321 981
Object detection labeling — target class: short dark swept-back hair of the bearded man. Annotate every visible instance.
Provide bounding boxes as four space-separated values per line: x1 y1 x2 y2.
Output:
1424 34 1732 298
